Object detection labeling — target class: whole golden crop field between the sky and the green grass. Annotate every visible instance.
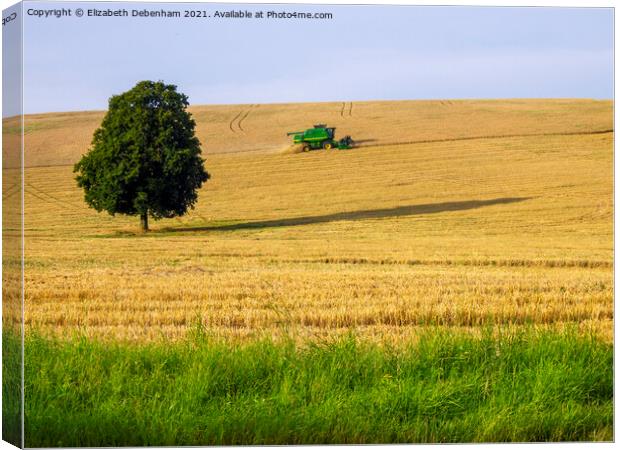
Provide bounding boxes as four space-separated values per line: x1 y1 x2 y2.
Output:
4 100 613 342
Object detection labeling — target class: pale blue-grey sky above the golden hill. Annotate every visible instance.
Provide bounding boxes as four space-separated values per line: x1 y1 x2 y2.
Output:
3 2 614 116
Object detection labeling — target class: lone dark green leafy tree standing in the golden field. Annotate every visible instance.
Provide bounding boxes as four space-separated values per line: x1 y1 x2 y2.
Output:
73 81 209 231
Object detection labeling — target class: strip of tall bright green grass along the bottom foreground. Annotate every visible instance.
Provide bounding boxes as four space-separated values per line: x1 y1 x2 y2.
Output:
25 329 613 447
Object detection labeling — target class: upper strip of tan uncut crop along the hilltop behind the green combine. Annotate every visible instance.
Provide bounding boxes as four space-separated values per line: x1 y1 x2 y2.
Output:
7 99 613 167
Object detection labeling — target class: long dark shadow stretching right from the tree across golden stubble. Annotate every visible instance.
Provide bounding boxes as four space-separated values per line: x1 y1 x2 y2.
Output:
161 197 532 232
